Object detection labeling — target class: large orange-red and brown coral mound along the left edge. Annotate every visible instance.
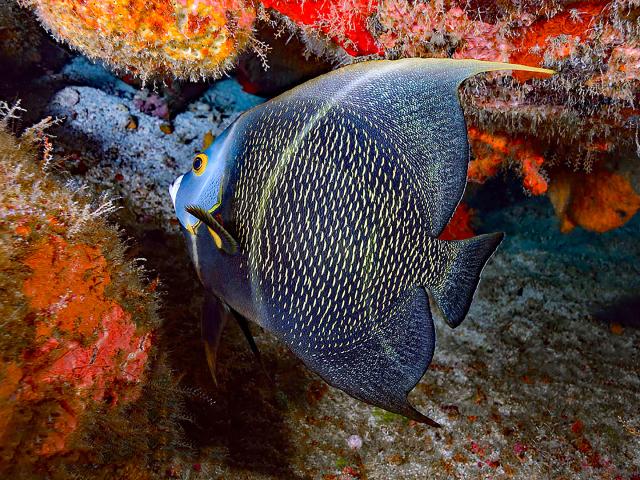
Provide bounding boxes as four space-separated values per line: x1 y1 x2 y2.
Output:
0 104 180 478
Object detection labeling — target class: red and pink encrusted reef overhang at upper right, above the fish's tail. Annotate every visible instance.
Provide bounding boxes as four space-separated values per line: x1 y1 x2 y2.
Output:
263 0 640 232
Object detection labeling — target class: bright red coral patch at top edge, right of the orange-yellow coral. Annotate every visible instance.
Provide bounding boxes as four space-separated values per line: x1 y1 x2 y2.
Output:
262 0 383 55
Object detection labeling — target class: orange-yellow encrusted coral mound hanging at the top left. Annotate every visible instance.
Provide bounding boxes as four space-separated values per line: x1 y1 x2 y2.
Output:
20 0 255 80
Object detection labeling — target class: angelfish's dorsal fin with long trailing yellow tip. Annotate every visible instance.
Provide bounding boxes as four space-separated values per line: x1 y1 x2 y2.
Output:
274 58 553 237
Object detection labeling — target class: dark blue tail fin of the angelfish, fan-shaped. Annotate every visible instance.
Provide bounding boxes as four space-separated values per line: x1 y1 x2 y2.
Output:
428 233 504 328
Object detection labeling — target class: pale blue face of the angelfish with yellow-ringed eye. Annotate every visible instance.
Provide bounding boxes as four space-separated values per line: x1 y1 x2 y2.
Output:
169 130 229 233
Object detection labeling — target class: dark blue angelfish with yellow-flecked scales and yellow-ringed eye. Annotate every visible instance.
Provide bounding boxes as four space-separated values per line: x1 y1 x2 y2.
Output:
170 58 553 427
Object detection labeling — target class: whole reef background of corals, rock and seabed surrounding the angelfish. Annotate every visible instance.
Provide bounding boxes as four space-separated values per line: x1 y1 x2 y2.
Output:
0 0 640 480
